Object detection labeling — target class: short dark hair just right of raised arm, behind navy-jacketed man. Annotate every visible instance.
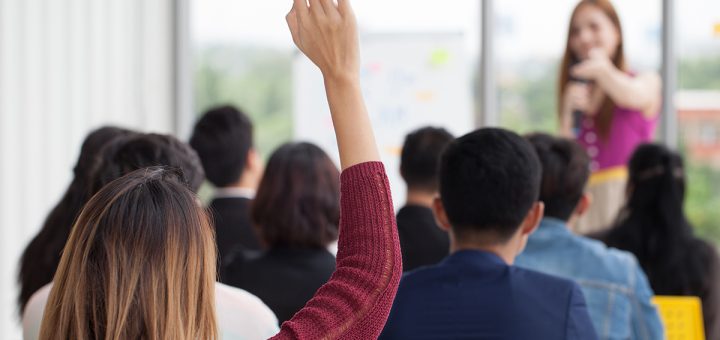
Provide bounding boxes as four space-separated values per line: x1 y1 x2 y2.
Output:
400 126 454 192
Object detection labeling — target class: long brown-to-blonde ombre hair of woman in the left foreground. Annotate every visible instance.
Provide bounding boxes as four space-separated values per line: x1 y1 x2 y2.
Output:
40 167 217 340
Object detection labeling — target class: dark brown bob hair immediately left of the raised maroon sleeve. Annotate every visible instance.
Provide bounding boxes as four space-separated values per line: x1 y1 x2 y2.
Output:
251 143 340 248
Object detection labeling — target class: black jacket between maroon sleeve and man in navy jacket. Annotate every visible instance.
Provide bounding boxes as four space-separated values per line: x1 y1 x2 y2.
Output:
397 205 450 272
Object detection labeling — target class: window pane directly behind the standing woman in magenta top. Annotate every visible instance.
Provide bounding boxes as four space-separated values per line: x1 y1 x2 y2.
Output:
494 0 662 133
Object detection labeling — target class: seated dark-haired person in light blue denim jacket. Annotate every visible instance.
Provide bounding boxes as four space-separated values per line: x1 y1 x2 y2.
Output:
515 134 663 339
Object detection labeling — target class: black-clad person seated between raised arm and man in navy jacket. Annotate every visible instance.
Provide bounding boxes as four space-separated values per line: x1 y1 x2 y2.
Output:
397 127 453 271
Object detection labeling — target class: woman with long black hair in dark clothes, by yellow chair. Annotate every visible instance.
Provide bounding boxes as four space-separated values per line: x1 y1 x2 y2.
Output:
606 144 717 295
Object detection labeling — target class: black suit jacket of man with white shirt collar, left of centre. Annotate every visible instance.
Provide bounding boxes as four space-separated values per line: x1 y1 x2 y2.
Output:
208 197 261 265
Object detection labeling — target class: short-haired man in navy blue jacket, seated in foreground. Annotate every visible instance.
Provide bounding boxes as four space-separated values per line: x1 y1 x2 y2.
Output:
380 128 597 339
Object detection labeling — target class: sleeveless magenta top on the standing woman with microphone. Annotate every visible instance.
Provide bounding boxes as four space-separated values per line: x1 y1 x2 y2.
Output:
577 107 658 171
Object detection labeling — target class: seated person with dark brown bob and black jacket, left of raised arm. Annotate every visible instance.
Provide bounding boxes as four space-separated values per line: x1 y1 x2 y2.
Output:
221 143 340 322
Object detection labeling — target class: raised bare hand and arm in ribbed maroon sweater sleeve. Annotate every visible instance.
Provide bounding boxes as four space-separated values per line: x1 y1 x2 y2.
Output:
277 0 402 339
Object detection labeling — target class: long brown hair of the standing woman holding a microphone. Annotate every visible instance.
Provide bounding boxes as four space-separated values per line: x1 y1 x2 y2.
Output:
557 0 627 138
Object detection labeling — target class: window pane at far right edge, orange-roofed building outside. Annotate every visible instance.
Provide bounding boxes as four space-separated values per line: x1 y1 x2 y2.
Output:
675 0 720 244
